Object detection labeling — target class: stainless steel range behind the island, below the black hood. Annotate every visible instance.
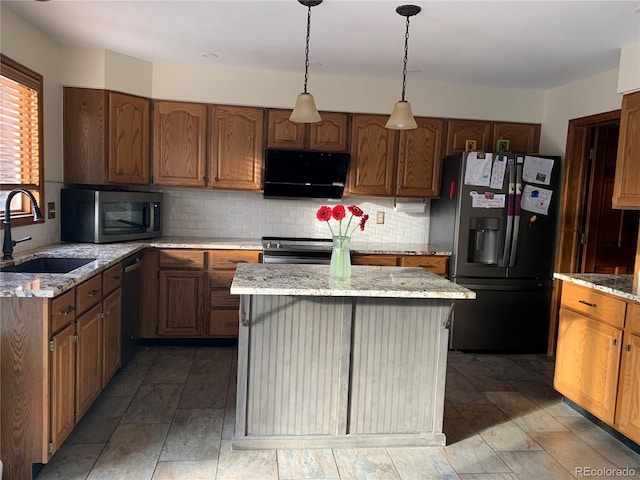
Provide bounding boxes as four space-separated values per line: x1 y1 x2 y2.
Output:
262 237 333 265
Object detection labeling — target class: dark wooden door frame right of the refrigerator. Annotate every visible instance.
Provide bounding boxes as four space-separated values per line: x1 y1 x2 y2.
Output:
548 110 621 354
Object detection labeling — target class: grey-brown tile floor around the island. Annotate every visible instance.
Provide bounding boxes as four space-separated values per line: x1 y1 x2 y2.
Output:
37 347 640 480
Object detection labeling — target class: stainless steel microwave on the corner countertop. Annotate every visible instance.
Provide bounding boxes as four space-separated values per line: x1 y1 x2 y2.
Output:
60 188 163 243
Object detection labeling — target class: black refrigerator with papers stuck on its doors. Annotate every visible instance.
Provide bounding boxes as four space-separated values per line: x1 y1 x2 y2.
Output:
429 152 561 353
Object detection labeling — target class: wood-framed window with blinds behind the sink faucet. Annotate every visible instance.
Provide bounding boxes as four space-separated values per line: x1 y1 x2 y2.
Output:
0 55 44 225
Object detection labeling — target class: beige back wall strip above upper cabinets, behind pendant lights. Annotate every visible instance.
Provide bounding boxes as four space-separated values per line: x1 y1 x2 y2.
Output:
152 63 544 123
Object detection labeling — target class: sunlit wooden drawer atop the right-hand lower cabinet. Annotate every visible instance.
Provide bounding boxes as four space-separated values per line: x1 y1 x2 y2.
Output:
562 282 626 328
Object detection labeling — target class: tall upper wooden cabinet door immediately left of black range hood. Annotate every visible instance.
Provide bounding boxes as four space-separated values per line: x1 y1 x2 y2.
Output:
211 105 264 190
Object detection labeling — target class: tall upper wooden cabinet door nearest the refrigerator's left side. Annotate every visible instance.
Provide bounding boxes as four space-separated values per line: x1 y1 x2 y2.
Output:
396 118 444 197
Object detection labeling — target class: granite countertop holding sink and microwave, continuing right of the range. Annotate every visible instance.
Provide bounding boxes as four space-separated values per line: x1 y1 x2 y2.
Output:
0 237 451 297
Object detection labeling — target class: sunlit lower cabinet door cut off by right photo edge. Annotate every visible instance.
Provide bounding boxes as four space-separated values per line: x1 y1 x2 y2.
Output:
616 335 640 443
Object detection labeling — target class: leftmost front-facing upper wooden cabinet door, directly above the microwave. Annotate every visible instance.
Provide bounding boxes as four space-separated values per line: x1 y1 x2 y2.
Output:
108 92 150 185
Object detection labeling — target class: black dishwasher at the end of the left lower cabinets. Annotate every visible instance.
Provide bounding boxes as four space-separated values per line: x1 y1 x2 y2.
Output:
120 254 142 366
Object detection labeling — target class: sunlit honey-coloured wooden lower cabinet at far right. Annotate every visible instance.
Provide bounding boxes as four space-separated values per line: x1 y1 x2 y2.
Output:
554 282 640 443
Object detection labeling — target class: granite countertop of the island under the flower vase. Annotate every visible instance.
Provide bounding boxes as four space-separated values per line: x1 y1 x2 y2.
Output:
231 263 476 299
